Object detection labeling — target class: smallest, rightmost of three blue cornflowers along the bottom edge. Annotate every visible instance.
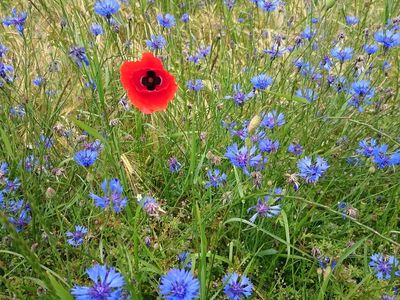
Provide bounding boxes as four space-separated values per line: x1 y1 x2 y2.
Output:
222 272 253 300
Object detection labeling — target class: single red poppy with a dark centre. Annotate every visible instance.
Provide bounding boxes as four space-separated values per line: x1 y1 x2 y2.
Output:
121 52 178 114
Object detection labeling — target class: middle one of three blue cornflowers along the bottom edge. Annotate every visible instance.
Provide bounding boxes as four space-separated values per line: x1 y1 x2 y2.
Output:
160 269 200 300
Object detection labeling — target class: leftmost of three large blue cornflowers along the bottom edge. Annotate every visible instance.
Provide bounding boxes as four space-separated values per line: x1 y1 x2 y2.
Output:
71 265 125 300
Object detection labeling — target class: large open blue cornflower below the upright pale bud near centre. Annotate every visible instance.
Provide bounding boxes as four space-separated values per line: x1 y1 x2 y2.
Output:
225 143 262 175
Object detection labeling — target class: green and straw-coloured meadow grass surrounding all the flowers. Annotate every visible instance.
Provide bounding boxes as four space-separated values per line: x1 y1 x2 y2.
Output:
0 0 400 299
